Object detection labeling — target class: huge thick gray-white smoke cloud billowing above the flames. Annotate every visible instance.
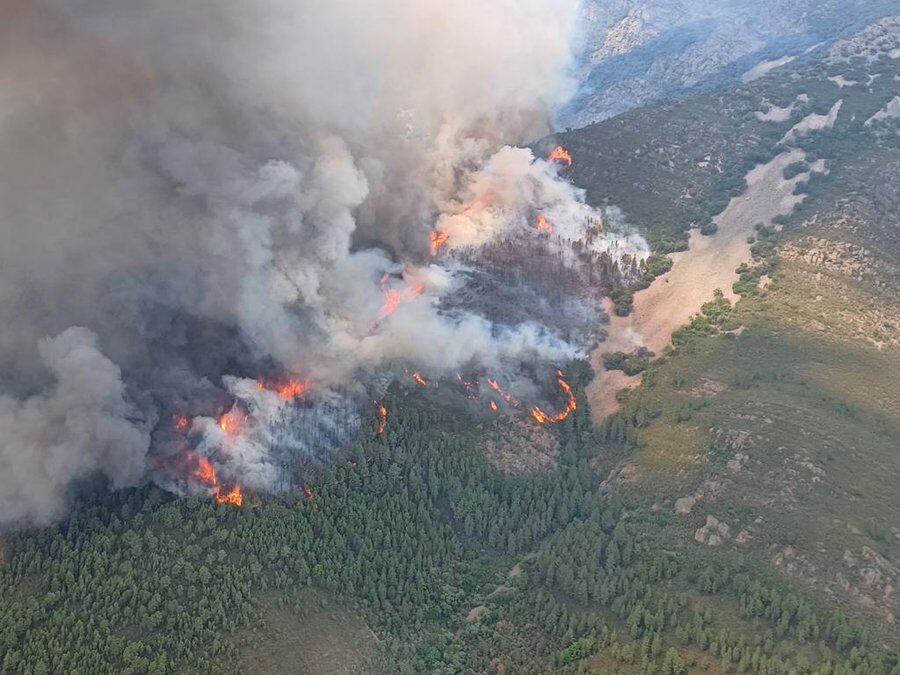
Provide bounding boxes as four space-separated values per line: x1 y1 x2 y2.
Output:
0 0 648 524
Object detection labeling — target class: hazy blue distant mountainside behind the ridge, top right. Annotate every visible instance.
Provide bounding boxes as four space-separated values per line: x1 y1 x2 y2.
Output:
559 0 896 128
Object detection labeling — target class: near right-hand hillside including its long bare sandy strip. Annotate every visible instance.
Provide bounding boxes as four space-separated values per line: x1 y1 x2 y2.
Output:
566 14 900 636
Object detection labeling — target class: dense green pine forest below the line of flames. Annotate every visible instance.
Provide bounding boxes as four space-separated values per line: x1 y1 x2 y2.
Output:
0 364 900 675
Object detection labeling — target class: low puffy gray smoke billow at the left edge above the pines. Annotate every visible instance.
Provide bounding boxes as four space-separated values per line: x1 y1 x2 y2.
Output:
0 328 150 524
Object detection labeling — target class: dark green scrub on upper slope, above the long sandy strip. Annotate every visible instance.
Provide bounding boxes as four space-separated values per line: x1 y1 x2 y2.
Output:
559 16 900 262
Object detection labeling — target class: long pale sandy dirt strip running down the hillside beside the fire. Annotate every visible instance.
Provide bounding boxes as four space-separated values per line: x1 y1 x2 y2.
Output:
588 150 809 421
